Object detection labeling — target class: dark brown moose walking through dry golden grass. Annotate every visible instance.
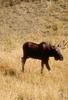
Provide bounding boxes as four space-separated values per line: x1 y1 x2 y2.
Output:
21 42 63 73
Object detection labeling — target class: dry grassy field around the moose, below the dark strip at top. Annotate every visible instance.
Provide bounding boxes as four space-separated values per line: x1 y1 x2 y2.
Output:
0 0 68 100
